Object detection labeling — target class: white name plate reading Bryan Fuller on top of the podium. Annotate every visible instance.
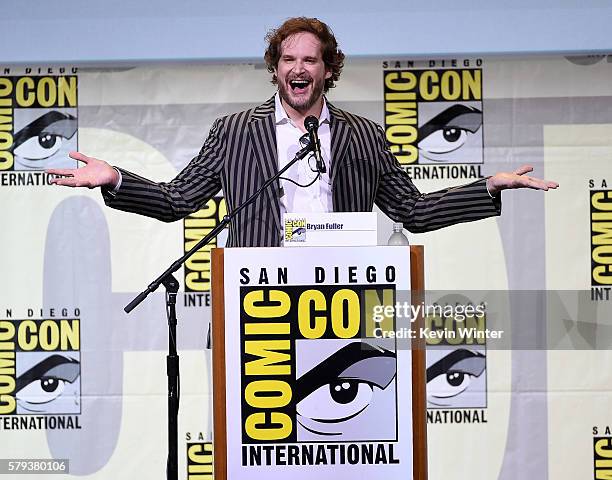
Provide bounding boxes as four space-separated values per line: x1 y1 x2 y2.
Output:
283 212 378 247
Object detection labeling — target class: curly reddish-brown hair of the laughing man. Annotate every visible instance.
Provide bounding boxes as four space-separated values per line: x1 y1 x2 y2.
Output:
264 17 344 92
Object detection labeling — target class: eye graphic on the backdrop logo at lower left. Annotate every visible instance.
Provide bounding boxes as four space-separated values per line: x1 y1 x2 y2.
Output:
15 355 81 412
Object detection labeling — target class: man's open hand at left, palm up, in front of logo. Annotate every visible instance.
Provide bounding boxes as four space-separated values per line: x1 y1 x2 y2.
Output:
47 152 119 188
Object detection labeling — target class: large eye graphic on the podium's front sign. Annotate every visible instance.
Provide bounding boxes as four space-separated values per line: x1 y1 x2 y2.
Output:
296 342 396 436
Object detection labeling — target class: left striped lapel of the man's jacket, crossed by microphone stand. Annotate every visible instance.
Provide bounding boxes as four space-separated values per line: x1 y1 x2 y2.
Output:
248 97 280 231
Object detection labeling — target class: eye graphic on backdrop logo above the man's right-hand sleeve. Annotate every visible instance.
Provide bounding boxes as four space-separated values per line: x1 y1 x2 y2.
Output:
418 104 482 162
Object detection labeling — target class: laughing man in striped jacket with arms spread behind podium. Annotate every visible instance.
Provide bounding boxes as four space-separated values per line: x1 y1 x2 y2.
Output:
48 17 558 246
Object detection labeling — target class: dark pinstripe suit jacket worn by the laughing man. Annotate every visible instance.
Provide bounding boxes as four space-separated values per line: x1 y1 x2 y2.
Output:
103 97 501 246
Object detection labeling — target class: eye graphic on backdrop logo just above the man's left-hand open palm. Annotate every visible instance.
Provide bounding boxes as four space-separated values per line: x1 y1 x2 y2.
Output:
13 111 77 163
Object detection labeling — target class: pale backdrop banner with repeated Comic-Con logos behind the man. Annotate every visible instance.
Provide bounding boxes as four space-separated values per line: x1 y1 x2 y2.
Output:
0 56 612 480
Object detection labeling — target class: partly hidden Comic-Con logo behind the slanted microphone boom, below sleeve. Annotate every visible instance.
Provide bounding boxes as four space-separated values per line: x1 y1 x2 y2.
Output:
183 197 227 307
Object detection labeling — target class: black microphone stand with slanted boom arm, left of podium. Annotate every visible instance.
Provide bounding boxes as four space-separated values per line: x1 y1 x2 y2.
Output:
123 139 313 480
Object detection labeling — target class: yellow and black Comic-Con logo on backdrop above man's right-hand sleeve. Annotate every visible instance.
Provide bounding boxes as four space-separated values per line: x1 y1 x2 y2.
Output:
382 59 484 179
